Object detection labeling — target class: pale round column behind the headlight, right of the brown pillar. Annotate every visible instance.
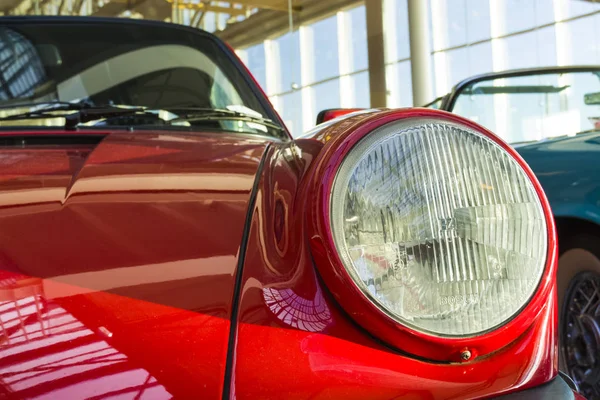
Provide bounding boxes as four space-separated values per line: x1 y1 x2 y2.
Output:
408 0 433 107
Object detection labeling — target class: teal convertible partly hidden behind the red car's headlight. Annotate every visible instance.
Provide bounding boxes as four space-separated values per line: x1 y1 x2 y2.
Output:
436 66 600 399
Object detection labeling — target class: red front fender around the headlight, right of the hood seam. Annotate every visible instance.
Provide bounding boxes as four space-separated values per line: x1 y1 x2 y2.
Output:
231 110 557 399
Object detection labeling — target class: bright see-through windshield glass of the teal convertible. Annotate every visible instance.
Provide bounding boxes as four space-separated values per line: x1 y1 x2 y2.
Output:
452 70 600 143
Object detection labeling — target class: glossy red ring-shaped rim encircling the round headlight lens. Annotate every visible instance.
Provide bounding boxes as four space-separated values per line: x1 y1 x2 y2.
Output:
307 109 557 362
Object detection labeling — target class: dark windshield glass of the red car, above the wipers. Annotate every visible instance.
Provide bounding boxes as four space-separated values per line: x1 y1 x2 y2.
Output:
0 20 274 135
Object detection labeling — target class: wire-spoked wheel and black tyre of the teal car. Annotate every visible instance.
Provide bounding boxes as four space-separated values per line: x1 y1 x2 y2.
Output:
557 235 600 399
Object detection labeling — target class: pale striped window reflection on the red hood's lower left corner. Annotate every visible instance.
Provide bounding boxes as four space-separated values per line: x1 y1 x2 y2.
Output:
0 288 171 399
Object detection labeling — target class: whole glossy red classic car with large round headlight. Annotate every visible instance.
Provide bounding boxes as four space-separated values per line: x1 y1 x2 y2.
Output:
0 17 582 400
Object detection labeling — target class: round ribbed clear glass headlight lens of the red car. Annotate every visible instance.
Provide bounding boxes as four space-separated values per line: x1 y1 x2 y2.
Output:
330 119 548 337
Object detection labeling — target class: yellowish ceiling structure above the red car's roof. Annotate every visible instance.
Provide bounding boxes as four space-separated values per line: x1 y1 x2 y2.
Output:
0 0 600 48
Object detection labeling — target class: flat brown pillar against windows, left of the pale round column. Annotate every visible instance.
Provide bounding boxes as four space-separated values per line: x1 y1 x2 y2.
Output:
365 0 386 107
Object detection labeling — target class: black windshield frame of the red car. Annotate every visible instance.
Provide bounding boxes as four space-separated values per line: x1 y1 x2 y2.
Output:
0 16 291 140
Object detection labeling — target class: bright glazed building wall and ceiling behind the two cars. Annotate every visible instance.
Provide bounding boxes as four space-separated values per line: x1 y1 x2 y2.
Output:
0 0 600 135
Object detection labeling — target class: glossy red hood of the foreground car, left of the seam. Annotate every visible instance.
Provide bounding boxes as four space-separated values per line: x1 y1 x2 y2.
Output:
0 131 268 398
